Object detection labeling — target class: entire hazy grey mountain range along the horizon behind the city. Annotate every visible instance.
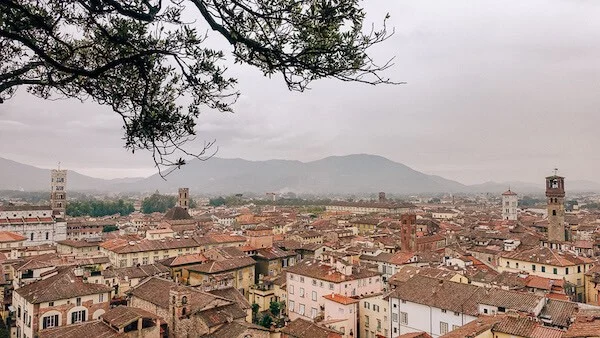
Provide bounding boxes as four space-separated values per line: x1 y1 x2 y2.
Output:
0 154 600 194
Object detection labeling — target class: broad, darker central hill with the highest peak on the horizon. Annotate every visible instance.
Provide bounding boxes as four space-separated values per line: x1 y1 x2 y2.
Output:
123 155 465 194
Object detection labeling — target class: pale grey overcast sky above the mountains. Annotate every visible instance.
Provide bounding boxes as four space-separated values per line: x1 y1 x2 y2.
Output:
0 0 600 183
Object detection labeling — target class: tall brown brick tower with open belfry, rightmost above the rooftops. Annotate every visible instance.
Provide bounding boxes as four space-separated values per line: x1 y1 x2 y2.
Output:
546 169 566 242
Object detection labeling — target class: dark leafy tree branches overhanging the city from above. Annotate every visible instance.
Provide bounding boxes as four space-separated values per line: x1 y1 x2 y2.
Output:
0 0 393 173
